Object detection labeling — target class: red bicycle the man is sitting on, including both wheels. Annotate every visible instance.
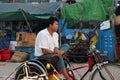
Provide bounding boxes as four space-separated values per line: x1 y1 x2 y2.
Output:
15 46 120 80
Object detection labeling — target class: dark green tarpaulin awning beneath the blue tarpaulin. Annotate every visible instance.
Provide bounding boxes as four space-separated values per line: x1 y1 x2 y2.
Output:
0 9 39 21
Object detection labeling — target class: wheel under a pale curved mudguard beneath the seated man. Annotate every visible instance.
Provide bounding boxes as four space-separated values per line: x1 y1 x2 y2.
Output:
15 62 47 80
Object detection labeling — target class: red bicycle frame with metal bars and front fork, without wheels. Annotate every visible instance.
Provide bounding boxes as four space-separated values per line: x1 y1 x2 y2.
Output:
13 45 114 80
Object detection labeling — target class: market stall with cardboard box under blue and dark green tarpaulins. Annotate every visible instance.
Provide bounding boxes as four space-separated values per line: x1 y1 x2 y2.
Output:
0 2 60 60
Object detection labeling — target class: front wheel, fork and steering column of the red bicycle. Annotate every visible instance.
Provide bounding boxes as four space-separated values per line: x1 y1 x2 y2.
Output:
90 48 120 80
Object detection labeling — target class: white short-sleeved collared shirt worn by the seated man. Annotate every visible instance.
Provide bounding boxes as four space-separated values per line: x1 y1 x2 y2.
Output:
35 28 59 56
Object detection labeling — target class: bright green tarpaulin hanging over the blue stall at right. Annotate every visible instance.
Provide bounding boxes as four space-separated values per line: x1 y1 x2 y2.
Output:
61 0 114 27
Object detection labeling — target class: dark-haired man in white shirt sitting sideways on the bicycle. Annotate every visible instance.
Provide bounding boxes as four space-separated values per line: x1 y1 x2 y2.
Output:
35 17 72 80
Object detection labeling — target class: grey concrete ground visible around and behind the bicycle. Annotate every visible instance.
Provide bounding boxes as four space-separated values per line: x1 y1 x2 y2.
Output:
0 61 120 80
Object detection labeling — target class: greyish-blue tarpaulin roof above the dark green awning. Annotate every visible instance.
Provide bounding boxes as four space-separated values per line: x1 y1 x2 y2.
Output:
0 2 61 15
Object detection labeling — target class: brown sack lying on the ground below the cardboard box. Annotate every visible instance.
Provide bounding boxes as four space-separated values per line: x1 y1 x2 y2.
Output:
11 51 29 62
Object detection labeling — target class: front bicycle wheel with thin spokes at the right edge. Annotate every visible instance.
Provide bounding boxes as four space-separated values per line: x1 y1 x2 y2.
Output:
90 63 120 80
